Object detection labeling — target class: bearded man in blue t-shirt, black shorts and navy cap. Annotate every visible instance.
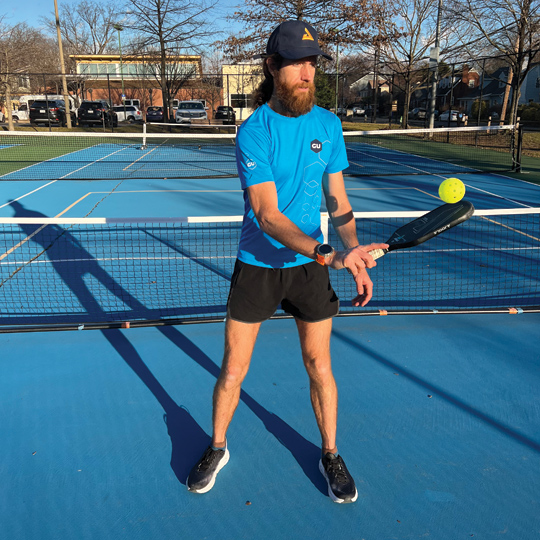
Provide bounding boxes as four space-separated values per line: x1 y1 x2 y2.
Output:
187 21 388 503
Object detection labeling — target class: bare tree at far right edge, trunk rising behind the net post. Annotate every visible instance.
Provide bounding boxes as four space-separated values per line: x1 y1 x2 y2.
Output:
447 0 540 123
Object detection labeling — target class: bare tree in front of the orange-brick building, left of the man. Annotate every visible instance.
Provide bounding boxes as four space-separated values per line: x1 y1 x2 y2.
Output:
124 0 217 121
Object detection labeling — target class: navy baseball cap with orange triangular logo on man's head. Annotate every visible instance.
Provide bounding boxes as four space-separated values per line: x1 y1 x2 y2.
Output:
253 21 332 60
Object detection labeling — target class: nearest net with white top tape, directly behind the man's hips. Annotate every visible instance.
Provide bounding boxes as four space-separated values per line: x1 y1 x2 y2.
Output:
0 208 540 331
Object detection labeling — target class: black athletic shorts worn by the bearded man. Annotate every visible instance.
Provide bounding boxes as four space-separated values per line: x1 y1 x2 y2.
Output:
227 260 339 323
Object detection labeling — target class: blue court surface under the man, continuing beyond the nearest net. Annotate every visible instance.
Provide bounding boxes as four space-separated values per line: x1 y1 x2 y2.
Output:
0 133 540 540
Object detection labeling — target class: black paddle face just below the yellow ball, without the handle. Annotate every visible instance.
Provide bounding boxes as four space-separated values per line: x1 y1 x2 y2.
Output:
386 201 474 251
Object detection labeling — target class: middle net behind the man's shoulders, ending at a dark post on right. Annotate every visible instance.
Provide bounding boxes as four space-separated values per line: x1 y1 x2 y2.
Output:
0 126 519 181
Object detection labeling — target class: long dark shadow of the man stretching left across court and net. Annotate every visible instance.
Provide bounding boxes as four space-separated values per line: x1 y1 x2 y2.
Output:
10 201 326 494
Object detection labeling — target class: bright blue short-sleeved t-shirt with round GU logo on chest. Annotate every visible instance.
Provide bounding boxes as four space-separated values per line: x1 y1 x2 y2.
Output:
236 105 349 268
